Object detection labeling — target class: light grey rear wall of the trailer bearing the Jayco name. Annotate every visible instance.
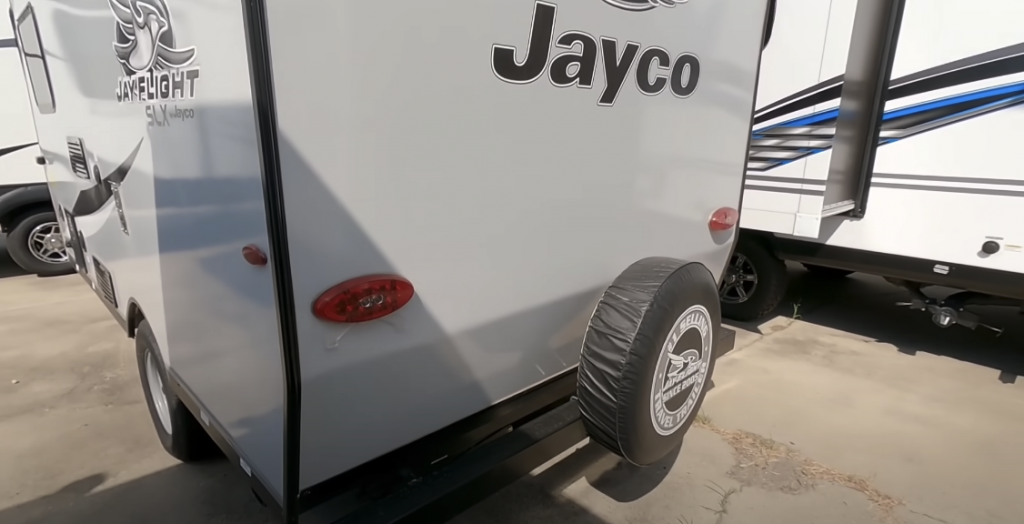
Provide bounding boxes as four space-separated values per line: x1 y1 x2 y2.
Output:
256 0 767 487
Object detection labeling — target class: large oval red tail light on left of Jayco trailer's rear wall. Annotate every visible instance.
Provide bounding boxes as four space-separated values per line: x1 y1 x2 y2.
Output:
313 275 414 323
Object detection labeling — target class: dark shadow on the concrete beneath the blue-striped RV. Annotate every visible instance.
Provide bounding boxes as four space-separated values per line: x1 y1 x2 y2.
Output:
732 264 1024 383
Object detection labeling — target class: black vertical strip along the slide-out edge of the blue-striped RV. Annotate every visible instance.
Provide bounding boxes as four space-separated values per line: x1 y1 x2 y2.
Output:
850 0 906 218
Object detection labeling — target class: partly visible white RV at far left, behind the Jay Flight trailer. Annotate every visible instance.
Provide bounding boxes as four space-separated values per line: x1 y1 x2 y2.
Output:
0 13 74 275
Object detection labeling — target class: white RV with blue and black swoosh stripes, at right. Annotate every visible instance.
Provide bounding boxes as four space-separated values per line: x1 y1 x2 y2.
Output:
721 0 1024 329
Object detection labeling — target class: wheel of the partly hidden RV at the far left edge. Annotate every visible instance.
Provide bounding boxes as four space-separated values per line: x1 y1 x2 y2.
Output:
7 210 75 276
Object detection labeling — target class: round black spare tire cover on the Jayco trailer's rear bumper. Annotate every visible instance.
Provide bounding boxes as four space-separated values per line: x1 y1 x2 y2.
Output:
578 258 721 466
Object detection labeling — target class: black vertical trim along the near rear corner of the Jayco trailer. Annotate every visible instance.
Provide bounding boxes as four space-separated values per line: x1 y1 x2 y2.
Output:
242 0 302 524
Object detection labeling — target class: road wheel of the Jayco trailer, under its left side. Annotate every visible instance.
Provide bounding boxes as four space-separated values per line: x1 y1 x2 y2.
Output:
135 320 216 463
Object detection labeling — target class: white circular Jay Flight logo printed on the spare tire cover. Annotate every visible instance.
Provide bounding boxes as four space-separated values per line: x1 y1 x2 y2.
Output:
650 305 714 436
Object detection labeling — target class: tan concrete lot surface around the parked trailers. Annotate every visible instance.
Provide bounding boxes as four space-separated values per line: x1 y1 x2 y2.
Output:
0 239 1024 524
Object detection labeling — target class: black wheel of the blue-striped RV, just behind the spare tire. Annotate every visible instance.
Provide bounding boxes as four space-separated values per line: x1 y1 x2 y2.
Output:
719 235 787 321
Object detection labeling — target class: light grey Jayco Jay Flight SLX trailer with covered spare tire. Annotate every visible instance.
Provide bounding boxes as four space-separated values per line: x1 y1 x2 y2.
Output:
11 0 771 523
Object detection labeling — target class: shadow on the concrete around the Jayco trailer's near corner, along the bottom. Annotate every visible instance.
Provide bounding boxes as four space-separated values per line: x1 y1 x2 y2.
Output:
0 444 679 524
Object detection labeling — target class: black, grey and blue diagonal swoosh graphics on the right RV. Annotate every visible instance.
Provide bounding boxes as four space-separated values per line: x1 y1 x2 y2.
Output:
746 43 1024 173
